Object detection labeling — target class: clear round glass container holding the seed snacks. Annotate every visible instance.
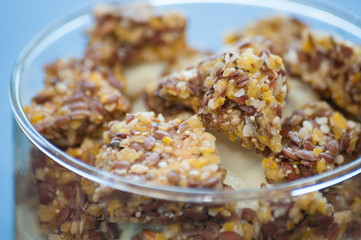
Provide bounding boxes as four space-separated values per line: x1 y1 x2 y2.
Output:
10 0 361 240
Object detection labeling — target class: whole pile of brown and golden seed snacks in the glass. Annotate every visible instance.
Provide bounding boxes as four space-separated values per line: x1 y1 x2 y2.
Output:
25 2 361 240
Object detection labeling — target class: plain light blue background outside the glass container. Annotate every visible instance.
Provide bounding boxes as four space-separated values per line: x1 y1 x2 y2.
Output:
0 0 361 240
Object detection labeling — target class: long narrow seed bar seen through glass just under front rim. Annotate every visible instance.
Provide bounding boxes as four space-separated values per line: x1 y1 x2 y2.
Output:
88 185 238 226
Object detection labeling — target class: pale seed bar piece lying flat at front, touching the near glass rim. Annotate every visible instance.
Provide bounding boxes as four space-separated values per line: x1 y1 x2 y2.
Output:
96 112 224 188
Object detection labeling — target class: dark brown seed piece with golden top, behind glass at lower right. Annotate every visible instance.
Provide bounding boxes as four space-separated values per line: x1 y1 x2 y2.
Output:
257 191 339 240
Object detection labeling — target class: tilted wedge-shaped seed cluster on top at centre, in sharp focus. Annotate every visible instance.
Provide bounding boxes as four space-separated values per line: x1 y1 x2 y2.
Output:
148 47 286 151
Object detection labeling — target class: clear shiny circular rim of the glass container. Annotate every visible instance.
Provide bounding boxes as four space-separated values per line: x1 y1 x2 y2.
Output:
9 0 361 203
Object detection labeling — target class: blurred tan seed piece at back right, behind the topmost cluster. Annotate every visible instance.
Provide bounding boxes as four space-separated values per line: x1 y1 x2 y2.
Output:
225 15 308 56
